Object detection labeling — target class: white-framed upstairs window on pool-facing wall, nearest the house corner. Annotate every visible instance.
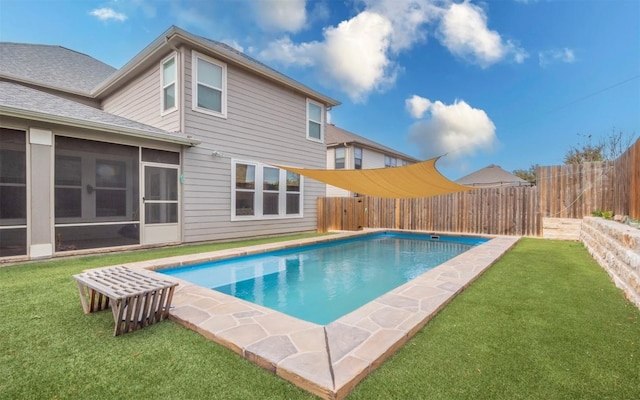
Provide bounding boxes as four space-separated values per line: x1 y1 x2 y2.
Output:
191 51 227 118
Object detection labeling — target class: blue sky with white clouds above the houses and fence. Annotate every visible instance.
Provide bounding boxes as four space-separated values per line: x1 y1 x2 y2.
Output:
0 0 640 179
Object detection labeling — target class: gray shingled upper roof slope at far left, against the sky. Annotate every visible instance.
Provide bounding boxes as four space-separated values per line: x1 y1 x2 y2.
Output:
0 42 116 96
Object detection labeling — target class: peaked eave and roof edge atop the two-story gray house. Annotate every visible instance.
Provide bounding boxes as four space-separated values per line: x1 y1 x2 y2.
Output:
93 26 340 107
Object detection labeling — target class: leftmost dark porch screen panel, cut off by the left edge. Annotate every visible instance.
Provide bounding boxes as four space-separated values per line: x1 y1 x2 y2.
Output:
0 128 27 257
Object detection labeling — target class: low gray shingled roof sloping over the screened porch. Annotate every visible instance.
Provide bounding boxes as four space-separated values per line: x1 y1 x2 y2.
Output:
0 82 199 145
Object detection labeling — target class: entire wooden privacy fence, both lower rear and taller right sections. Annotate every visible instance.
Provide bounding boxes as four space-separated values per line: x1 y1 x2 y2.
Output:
318 139 640 236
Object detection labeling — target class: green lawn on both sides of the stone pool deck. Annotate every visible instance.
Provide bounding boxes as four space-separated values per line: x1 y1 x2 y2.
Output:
0 238 640 399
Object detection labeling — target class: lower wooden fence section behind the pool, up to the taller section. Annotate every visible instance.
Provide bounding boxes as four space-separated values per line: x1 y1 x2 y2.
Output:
318 187 542 236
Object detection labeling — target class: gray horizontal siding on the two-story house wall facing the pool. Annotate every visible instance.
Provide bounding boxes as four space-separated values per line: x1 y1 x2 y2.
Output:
183 48 326 242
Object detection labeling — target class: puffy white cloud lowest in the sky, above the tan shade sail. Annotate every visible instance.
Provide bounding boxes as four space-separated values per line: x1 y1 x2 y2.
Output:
406 95 497 163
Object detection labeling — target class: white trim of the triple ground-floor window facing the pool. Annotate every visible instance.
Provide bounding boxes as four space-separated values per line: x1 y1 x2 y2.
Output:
231 159 304 221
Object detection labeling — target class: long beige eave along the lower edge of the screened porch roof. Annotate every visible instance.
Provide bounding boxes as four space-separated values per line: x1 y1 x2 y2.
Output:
0 106 200 146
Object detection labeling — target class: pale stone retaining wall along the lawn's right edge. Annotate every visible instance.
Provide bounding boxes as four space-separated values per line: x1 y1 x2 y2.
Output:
580 217 640 308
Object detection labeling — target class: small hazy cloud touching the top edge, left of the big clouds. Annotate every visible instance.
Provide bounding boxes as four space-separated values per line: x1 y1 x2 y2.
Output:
251 0 307 32
